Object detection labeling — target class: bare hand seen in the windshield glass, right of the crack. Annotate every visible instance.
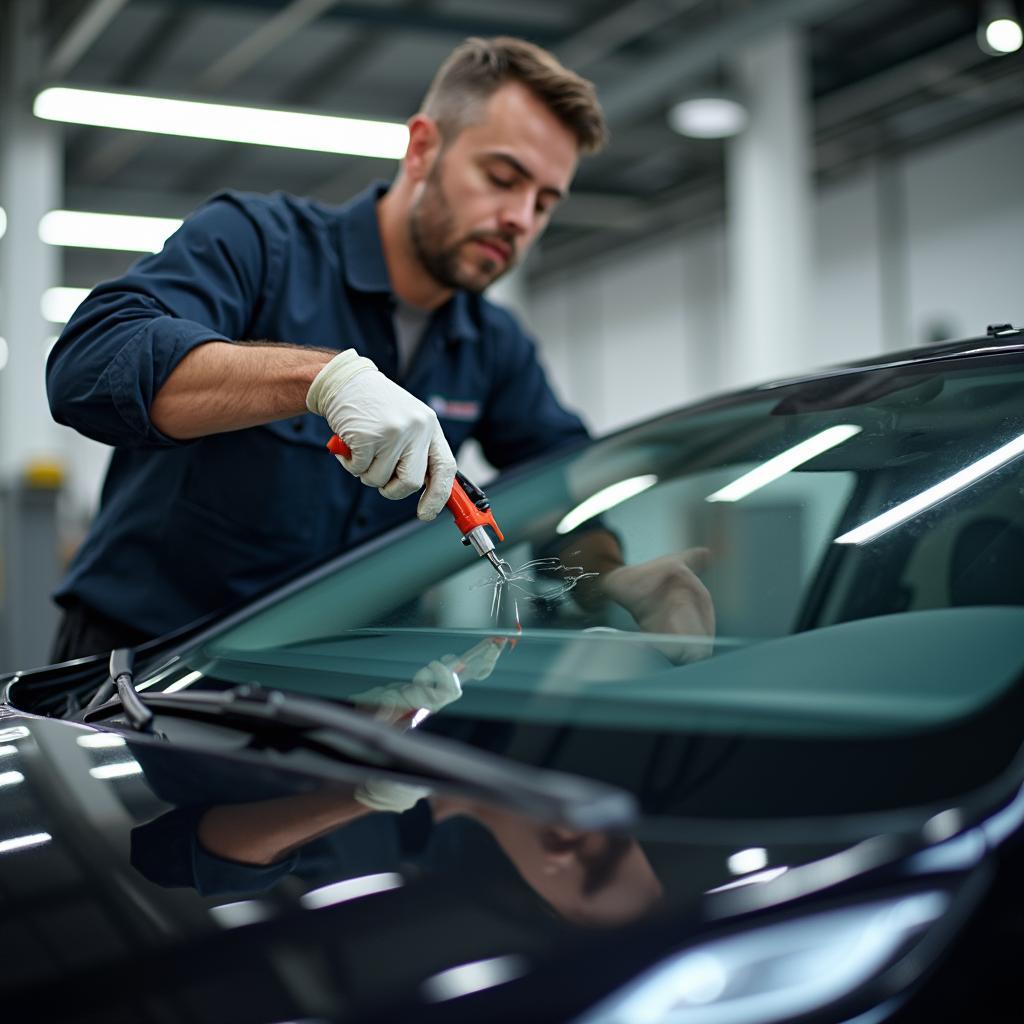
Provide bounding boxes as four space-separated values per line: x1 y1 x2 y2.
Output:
599 548 715 662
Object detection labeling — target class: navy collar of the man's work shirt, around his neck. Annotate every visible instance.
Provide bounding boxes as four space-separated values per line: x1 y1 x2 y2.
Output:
341 181 480 341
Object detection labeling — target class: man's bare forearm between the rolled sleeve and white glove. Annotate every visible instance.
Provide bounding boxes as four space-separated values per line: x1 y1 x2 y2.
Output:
150 341 337 440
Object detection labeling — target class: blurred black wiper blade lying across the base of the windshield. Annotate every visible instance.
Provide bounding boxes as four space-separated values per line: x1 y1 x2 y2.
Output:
136 687 638 830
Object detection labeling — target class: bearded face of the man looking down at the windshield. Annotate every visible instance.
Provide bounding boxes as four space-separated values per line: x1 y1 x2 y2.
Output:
409 83 578 292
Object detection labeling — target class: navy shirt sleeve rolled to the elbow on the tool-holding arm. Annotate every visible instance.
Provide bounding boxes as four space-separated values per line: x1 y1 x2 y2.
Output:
46 194 272 446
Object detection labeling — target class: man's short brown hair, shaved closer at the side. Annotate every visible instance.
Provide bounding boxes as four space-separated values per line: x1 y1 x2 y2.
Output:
422 36 608 153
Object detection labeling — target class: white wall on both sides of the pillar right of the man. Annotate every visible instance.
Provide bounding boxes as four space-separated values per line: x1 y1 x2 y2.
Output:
529 111 1024 431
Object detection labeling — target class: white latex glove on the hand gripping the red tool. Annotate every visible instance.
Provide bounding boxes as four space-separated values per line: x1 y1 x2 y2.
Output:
306 348 456 520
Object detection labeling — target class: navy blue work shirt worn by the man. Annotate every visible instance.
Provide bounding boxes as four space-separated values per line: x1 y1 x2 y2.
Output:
46 183 587 636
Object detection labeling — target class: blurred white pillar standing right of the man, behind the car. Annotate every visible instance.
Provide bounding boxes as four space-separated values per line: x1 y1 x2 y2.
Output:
724 28 820 384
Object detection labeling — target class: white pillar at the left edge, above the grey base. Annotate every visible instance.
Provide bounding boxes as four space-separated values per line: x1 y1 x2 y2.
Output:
0 0 63 481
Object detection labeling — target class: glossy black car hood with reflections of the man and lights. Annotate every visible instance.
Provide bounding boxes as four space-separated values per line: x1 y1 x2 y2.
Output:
0 688 1015 1021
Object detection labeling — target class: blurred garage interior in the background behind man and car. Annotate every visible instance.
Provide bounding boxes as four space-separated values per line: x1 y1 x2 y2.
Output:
0 0 1024 671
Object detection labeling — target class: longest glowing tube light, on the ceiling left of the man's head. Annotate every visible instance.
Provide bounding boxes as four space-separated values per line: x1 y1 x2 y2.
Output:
33 86 409 160
